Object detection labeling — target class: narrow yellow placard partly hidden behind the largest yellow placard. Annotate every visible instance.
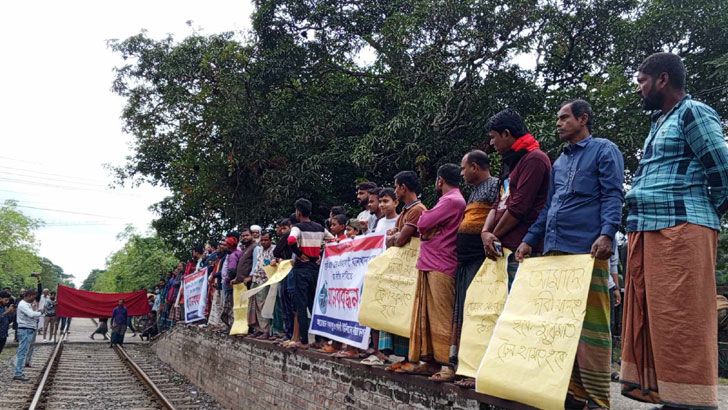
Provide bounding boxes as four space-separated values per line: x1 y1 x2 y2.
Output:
456 249 511 377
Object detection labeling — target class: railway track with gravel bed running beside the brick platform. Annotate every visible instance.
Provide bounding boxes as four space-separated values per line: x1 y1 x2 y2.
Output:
0 339 198 410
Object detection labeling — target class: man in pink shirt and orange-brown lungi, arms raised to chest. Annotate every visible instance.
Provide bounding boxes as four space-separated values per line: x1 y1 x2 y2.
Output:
401 164 465 381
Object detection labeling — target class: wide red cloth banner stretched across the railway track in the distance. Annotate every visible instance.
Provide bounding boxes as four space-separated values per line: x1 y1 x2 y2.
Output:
56 285 150 318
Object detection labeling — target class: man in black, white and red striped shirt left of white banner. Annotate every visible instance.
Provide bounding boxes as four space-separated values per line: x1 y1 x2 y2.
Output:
288 198 334 348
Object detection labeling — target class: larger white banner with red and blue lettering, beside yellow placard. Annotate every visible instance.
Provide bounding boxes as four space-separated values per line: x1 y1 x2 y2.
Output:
309 234 385 349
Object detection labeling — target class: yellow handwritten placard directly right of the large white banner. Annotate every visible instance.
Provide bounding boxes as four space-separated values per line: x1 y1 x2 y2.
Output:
359 238 420 337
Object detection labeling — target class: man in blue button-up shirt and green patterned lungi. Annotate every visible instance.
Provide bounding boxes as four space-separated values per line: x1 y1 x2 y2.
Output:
516 99 624 409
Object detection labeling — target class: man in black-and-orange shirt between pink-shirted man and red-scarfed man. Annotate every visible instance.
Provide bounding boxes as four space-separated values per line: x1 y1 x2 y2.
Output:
450 150 499 388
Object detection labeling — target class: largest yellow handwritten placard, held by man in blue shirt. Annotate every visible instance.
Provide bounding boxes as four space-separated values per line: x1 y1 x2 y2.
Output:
476 255 594 410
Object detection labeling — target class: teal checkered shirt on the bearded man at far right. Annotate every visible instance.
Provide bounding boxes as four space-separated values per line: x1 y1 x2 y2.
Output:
625 95 728 232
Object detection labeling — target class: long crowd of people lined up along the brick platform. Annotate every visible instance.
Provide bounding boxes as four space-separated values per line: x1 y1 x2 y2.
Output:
0 53 728 409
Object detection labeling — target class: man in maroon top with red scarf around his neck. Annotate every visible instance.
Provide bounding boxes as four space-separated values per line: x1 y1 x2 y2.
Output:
480 109 551 288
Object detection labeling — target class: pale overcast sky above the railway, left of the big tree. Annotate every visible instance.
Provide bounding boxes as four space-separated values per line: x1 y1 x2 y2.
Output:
0 0 253 285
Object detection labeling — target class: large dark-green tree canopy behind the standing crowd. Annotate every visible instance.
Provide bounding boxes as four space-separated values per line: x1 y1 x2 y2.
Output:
110 0 728 262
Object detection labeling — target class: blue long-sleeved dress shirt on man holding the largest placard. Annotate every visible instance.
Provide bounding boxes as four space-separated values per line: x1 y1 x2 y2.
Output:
523 135 624 253
